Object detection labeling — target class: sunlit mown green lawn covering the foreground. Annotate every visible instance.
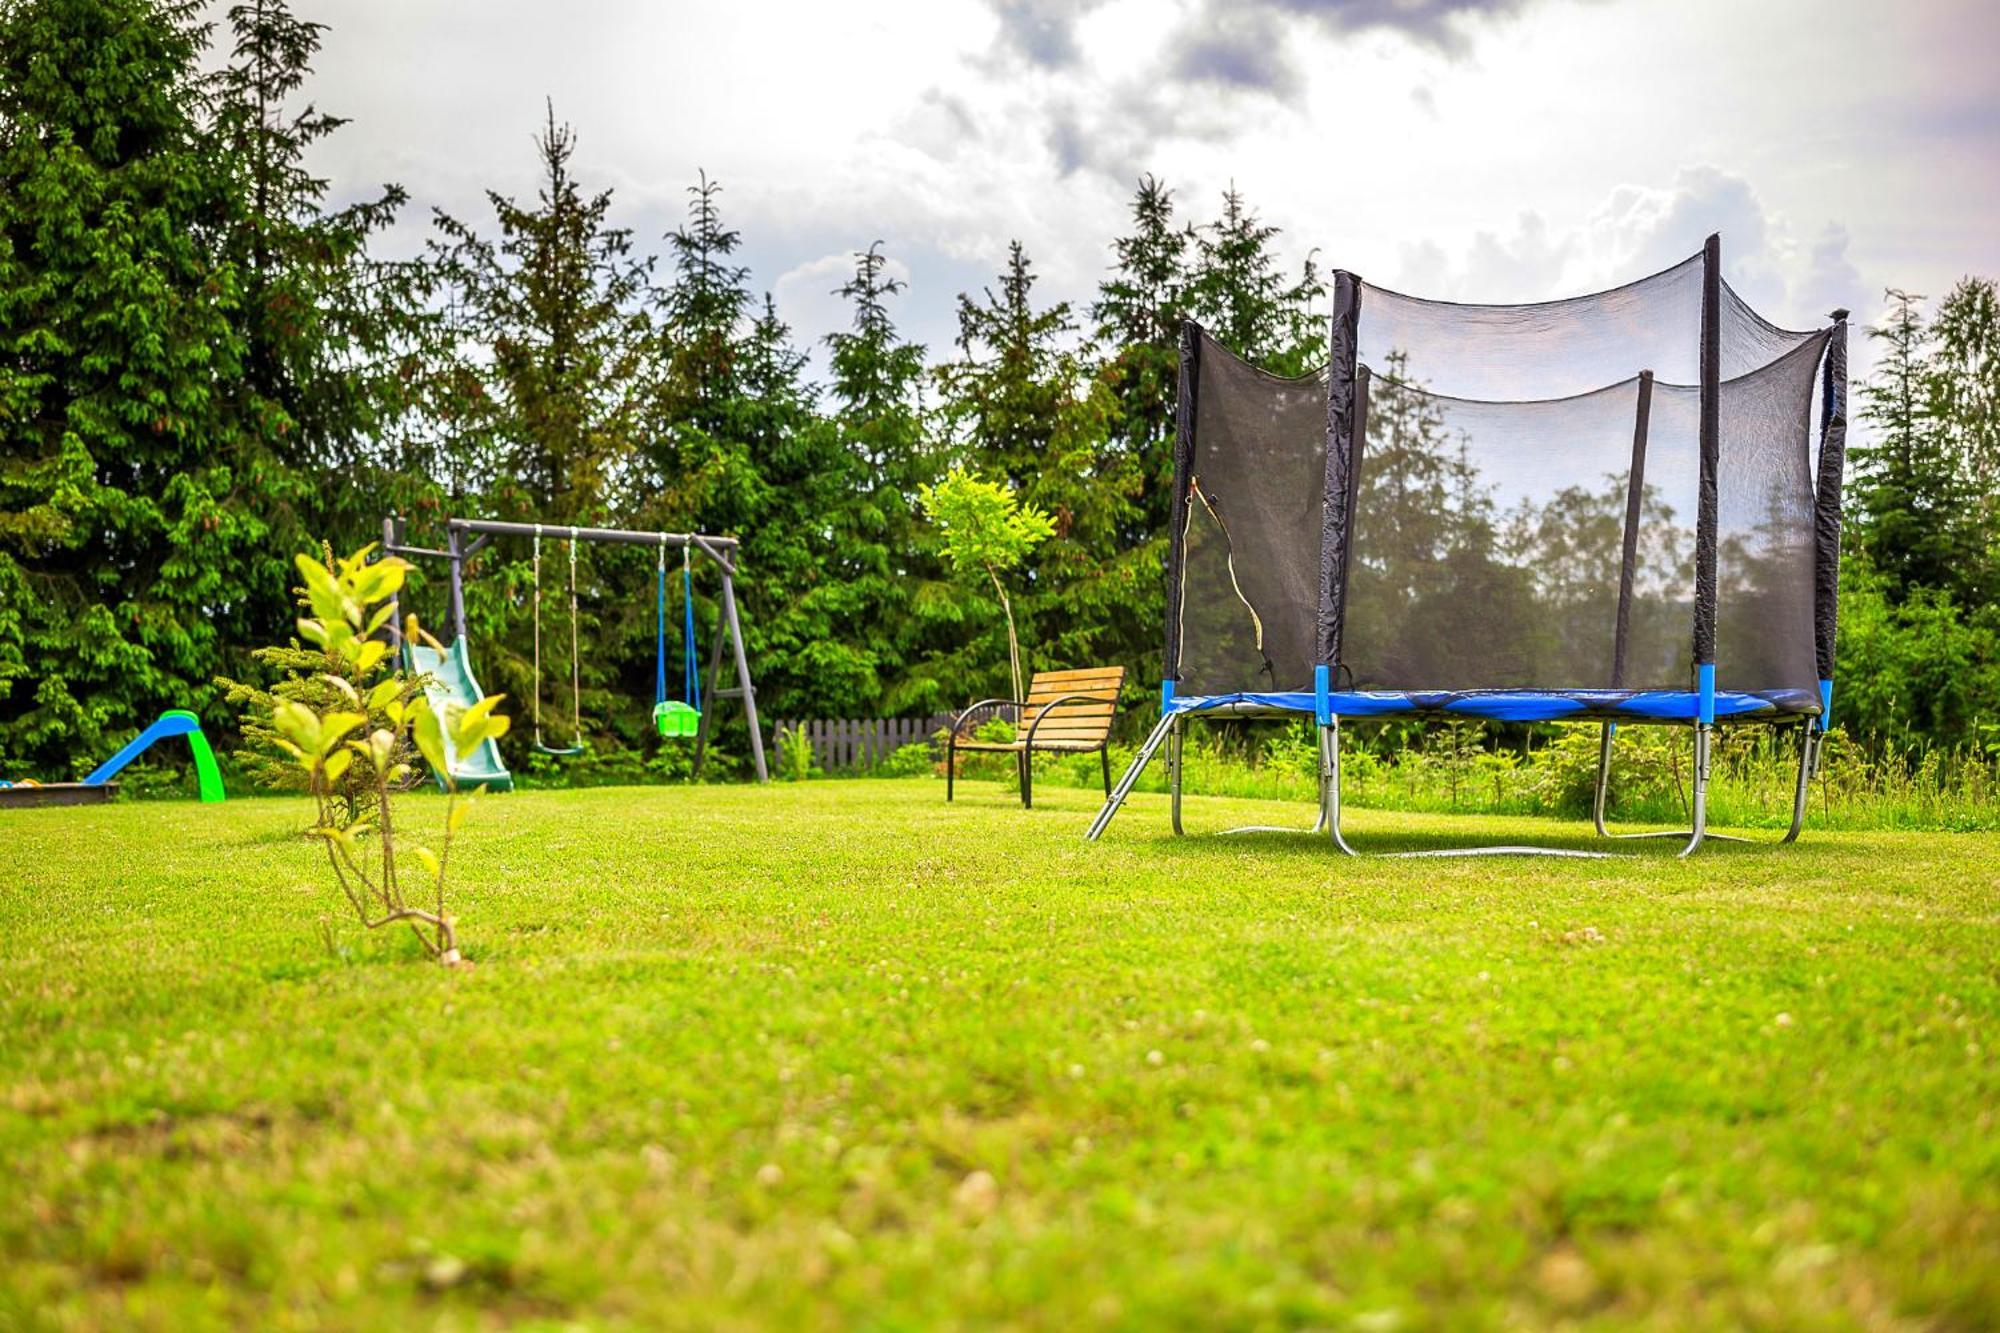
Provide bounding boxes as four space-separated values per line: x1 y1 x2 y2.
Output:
0 781 2000 1329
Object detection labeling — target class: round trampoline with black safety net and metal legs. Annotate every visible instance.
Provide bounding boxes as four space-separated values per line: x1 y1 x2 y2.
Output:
1088 236 1848 855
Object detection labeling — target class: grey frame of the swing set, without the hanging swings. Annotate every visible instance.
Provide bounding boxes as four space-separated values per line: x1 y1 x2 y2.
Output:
382 514 770 783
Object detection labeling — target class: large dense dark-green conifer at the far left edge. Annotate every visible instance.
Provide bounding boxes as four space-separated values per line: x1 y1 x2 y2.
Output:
0 0 260 779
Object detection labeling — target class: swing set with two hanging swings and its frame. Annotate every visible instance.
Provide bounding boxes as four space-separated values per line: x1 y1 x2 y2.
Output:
382 516 770 783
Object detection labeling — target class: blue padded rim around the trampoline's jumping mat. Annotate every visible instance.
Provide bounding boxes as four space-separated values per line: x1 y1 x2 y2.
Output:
1170 691 1820 723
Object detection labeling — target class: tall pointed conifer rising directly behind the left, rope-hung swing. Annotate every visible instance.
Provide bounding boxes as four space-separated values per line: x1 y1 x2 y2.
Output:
430 106 654 745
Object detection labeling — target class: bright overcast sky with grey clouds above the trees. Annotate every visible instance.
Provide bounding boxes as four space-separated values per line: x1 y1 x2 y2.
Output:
270 0 2000 378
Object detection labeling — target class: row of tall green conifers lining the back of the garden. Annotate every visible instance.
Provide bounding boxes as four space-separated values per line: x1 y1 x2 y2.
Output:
0 0 2000 777
